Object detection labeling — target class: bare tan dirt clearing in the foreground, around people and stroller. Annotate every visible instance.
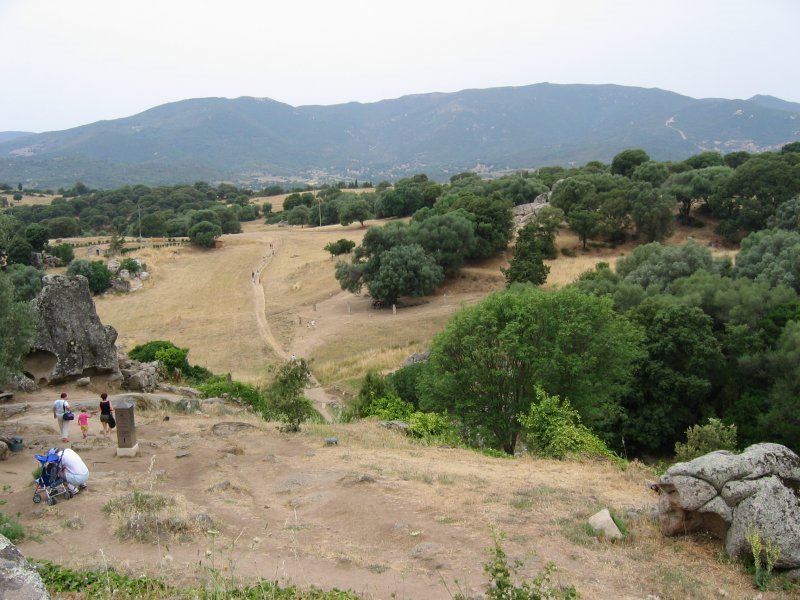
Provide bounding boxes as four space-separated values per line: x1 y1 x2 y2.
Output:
0 382 769 599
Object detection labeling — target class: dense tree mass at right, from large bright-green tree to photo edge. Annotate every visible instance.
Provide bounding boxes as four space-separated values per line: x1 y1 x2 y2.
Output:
370 230 800 456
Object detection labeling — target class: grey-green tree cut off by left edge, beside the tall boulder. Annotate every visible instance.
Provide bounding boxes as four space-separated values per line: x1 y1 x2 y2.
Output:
0 271 36 385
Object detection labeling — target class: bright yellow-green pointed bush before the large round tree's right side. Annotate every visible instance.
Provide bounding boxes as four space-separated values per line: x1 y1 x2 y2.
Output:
517 388 620 461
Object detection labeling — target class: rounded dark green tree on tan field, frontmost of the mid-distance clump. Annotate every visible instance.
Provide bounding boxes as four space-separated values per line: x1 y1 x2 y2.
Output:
366 244 444 304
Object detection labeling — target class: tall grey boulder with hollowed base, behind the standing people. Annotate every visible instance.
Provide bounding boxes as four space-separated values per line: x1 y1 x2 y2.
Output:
25 275 118 383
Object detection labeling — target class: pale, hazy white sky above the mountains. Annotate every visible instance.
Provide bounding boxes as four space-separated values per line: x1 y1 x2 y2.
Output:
0 0 800 132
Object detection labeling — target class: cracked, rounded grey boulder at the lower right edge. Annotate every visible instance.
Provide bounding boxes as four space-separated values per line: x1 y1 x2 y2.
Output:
656 444 800 569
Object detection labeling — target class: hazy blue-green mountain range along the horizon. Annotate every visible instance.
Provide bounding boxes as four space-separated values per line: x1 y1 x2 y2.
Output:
0 83 800 188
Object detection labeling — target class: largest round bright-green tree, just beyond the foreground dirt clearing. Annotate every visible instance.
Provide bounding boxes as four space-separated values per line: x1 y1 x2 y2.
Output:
420 286 642 453
